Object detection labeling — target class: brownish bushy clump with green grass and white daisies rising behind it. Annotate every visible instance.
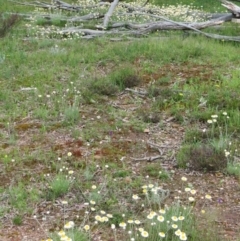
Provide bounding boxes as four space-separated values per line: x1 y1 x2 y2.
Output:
177 112 232 172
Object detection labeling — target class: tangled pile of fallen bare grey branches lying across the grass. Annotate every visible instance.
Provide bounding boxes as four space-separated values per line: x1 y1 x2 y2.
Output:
10 0 240 42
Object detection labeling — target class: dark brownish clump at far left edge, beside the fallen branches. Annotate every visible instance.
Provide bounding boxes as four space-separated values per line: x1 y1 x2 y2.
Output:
0 13 20 38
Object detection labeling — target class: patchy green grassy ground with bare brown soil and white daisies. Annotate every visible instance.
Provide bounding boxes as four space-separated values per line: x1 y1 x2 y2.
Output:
0 0 240 241
